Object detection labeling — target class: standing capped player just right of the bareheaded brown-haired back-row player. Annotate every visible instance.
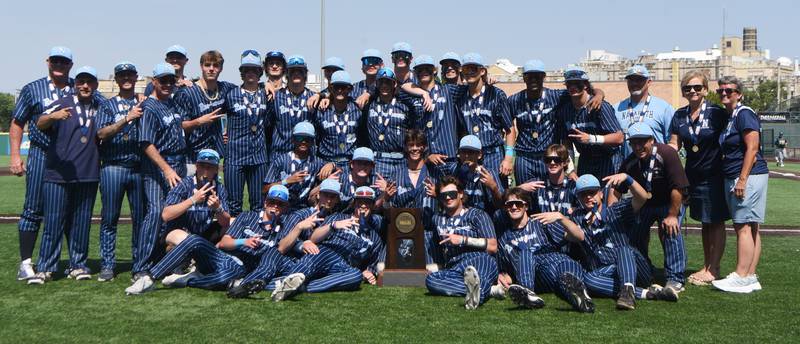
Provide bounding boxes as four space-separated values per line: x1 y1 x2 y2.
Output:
224 50 269 217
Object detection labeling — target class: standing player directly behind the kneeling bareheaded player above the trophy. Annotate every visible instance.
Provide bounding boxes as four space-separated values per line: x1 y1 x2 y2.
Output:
414 55 466 177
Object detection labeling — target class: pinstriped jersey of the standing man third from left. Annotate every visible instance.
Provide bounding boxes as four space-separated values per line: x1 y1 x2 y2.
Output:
97 96 142 167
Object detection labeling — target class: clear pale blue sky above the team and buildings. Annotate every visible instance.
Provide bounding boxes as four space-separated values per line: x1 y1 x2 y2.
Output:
0 0 800 93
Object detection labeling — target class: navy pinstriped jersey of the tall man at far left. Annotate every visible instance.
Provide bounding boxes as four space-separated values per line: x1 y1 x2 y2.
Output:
13 77 75 149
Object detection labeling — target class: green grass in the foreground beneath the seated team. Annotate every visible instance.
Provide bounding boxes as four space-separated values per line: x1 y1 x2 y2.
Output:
0 225 800 343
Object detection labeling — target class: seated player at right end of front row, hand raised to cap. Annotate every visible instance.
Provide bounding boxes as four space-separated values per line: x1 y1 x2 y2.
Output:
544 173 677 310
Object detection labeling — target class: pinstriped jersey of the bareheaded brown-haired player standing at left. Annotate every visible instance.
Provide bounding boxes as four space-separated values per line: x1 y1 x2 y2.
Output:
173 81 236 163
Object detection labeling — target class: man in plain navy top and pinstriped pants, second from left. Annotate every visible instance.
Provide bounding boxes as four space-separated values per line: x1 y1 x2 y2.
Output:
28 67 105 284
